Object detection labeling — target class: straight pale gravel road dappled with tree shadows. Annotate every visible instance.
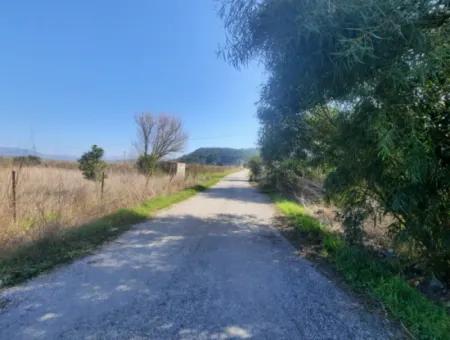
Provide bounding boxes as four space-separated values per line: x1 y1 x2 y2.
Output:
0 171 392 340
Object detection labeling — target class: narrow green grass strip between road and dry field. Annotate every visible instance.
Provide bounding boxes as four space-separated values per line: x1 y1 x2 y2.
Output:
0 172 229 287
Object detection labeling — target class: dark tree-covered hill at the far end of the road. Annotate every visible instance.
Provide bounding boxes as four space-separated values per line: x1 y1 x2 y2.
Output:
179 148 259 165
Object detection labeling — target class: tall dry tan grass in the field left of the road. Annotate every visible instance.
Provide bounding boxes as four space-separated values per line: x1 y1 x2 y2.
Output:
0 166 224 256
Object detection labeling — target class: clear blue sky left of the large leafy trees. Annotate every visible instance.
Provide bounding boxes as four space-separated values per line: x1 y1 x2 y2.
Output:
0 0 264 157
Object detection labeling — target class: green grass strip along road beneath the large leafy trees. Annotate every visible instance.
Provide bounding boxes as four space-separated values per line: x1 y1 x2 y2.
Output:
272 195 450 339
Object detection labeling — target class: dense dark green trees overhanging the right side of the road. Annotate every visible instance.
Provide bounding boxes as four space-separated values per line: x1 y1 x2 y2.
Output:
221 0 450 280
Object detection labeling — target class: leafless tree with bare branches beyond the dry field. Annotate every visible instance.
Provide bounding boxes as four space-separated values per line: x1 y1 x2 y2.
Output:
135 113 187 176
